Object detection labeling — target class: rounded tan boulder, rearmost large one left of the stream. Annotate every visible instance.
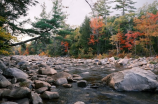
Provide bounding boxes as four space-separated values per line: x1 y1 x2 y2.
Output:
38 67 57 75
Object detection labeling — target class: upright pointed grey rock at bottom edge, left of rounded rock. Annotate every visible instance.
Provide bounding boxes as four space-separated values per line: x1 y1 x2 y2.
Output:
31 91 43 104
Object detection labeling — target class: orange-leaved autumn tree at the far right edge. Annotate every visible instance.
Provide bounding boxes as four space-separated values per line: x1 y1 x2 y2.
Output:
134 12 158 56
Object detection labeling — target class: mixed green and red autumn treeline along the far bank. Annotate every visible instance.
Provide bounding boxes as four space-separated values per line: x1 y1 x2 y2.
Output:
1 0 158 58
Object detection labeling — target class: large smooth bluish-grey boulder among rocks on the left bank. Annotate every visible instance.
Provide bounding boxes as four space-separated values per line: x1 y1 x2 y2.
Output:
3 68 28 79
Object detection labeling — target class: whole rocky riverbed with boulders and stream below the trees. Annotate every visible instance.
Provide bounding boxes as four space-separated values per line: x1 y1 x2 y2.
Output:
0 55 158 104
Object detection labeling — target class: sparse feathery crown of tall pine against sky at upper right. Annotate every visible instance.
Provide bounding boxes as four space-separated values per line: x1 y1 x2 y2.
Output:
114 0 136 15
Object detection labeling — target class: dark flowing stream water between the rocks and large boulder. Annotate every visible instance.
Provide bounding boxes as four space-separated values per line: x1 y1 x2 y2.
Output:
44 65 158 104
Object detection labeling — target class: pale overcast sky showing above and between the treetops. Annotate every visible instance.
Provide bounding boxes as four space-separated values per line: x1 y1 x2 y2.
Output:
24 0 155 26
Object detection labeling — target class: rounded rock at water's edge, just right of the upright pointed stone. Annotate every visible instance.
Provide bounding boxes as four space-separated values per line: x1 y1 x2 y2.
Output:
41 91 59 99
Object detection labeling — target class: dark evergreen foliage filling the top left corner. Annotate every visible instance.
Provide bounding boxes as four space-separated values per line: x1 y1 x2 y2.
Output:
0 0 38 29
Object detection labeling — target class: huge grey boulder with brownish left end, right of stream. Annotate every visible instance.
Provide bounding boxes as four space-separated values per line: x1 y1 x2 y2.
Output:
102 67 158 91
